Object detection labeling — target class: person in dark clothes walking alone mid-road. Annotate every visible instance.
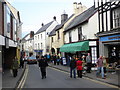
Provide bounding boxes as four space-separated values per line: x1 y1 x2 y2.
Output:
38 56 48 79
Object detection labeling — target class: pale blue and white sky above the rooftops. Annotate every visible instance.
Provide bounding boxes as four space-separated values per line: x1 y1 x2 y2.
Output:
7 0 94 37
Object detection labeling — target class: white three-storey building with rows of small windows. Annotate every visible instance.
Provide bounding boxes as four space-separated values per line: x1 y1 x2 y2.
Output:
34 17 58 55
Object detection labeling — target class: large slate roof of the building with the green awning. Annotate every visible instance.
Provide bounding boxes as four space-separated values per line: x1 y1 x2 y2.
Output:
64 6 97 32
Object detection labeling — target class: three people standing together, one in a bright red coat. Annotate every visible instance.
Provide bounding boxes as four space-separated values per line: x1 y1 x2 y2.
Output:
70 53 92 78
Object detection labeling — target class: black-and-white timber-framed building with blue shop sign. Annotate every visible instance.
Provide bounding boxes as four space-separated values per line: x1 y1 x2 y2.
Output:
97 0 120 64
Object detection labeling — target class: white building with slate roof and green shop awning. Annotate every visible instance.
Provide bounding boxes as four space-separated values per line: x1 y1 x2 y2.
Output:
60 6 98 63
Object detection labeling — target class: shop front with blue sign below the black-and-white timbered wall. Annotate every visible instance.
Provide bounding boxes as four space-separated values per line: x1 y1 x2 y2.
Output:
99 34 120 64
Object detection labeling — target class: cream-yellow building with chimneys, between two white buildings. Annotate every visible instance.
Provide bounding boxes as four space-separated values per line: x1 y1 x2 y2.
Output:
50 2 87 56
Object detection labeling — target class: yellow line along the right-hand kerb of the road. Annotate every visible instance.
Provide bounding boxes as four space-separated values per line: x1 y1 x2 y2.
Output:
49 67 119 88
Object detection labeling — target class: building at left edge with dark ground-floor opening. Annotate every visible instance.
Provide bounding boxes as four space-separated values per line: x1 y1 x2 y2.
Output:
0 0 22 69
